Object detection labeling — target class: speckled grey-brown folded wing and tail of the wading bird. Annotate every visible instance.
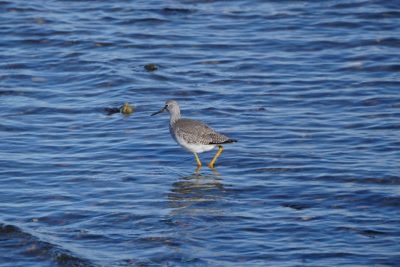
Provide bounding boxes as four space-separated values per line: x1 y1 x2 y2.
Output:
171 119 231 145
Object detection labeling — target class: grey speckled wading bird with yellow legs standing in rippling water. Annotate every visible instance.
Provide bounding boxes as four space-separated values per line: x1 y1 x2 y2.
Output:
151 100 236 168
